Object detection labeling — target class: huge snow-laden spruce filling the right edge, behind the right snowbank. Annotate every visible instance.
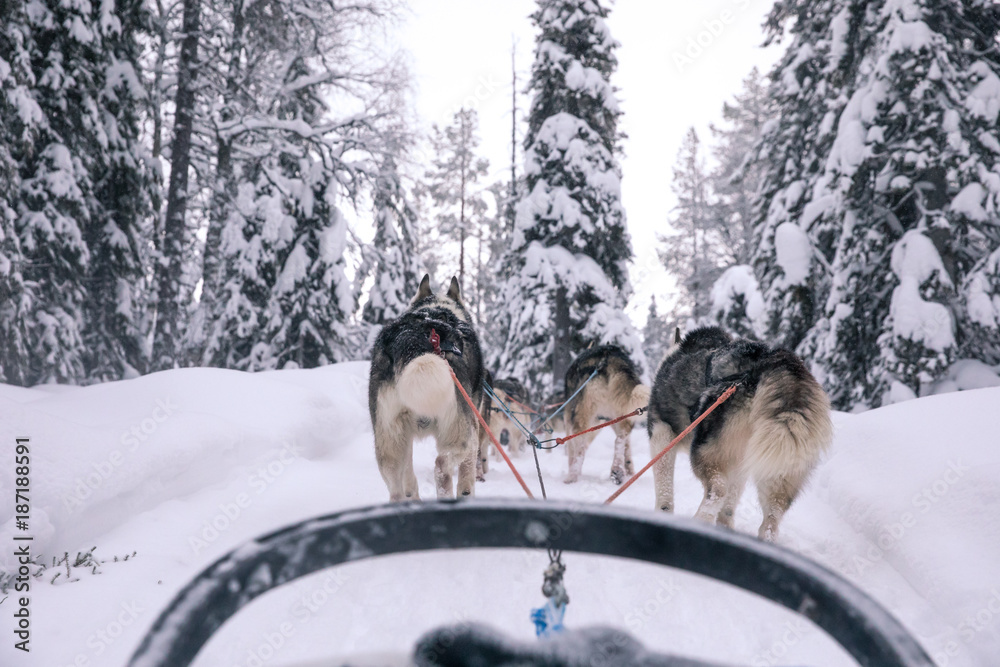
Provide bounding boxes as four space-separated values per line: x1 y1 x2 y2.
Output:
755 0 1000 409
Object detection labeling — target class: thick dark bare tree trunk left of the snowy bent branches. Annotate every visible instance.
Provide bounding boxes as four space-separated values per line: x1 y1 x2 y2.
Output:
152 0 201 370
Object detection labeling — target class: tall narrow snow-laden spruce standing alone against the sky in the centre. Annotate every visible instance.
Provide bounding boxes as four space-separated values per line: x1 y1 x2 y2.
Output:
495 0 645 395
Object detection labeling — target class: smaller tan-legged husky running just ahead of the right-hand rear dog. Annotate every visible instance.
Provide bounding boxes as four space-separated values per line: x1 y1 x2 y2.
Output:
564 345 649 484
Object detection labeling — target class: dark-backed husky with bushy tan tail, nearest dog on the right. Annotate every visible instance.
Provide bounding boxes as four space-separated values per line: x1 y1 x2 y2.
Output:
648 327 833 542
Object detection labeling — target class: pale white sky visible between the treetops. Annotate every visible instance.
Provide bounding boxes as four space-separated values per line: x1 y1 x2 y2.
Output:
401 0 781 327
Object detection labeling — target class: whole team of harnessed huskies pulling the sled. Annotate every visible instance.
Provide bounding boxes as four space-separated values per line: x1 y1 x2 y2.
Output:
368 276 833 541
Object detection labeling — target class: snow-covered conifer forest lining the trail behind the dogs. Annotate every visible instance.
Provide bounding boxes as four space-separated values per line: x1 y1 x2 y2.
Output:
0 0 1000 410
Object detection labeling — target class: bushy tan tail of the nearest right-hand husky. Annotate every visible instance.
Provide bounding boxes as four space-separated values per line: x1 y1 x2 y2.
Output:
744 376 833 480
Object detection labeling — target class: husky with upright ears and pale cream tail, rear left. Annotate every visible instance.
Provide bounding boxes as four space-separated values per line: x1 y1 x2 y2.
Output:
368 275 485 502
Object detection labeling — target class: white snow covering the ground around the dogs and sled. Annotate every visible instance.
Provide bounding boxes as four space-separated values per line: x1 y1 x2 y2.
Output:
0 363 1000 667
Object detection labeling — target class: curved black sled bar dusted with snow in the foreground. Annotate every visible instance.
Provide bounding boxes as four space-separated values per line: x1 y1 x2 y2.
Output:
129 499 934 667
